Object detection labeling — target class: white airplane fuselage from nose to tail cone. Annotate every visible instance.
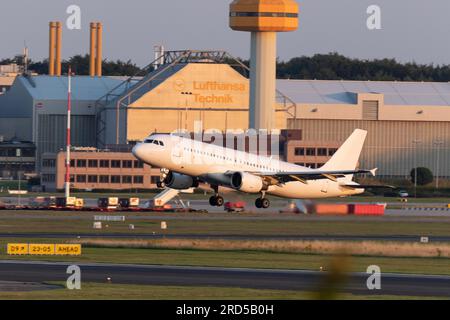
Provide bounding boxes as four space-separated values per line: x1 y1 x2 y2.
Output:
133 134 364 199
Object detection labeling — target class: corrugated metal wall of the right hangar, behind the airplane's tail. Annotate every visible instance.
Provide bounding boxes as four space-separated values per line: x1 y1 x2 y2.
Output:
288 119 450 177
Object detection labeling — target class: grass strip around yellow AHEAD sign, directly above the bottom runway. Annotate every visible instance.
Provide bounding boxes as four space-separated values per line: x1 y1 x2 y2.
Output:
0 239 450 275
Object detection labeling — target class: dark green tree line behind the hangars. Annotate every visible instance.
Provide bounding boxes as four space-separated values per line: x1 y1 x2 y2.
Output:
0 53 450 82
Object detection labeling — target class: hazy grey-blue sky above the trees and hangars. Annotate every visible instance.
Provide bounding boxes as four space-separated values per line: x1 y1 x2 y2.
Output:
0 0 450 66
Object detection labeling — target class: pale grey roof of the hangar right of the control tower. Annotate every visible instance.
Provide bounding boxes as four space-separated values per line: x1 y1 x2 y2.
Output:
277 80 450 106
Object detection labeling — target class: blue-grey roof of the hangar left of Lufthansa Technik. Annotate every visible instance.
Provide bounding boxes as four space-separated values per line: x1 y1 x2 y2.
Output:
16 76 125 101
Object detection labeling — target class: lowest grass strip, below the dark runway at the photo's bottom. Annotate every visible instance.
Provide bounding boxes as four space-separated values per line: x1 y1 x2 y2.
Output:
0 283 442 300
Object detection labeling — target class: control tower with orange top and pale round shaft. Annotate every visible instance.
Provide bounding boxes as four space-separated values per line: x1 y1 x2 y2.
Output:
230 0 298 130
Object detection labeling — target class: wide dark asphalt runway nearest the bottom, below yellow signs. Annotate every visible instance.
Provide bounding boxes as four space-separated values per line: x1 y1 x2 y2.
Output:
0 261 450 297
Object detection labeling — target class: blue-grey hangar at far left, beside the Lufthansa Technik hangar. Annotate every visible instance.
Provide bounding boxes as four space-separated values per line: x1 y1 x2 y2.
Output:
0 76 128 167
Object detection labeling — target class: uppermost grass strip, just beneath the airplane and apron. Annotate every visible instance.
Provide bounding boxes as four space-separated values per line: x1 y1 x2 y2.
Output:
0 211 450 237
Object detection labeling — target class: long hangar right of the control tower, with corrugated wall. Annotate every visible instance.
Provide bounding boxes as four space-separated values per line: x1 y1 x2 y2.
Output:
277 80 450 177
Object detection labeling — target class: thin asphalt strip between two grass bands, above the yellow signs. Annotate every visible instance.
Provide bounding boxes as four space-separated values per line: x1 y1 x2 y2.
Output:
0 232 450 242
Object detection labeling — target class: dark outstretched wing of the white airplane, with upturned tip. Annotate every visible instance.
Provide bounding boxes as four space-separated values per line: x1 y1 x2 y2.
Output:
241 169 377 184
